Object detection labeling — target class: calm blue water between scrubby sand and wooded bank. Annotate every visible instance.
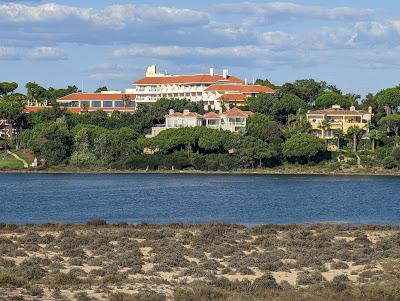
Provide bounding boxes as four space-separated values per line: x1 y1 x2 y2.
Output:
0 174 400 224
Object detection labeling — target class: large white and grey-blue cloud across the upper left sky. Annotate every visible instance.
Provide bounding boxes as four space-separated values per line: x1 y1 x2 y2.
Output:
0 3 209 46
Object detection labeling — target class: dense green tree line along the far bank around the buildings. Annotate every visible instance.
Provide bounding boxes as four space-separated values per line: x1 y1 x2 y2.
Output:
0 79 400 170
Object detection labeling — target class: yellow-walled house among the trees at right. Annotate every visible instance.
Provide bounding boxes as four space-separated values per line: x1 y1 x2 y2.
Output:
307 105 373 139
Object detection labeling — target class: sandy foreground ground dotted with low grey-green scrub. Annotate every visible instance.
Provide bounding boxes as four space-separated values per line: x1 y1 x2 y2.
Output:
0 221 400 301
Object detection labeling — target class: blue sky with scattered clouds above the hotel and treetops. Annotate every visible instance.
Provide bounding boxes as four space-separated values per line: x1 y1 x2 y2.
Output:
0 0 400 94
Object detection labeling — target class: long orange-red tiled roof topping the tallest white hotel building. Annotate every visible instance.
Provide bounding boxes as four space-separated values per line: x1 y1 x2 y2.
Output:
133 74 244 85
